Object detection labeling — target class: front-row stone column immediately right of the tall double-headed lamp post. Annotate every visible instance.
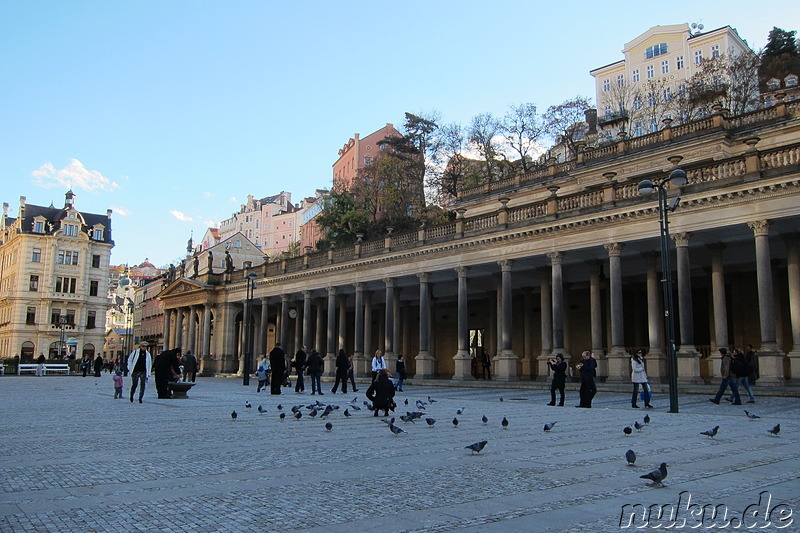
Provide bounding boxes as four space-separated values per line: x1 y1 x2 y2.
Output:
673 233 703 383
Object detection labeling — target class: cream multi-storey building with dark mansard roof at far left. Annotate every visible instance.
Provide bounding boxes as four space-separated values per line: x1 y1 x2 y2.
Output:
0 191 114 361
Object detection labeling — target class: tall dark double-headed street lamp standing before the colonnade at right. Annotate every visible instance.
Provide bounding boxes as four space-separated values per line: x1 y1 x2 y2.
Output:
639 168 686 413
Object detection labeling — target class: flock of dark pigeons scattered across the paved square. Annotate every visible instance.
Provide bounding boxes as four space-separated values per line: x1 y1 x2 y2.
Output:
231 396 781 487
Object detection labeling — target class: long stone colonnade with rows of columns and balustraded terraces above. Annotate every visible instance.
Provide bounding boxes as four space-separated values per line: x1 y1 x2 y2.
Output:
160 102 800 386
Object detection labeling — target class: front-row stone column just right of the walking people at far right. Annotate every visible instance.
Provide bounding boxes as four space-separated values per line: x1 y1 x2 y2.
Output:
747 220 784 384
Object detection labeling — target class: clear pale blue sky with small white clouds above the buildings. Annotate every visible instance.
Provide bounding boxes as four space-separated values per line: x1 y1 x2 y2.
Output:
0 0 800 266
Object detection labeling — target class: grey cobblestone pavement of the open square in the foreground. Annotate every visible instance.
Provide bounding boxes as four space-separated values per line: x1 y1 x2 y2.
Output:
0 374 800 533
